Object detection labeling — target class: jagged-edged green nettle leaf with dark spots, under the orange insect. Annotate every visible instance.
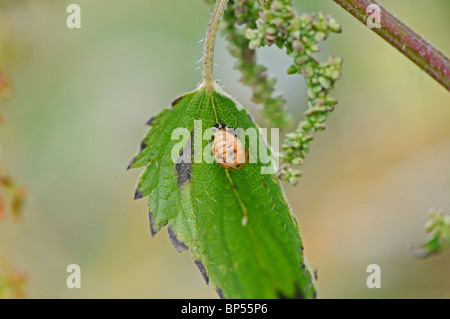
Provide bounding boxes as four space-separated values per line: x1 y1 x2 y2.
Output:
129 86 315 298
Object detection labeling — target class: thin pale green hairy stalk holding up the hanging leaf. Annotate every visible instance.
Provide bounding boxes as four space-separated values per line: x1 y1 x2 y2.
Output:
203 0 228 89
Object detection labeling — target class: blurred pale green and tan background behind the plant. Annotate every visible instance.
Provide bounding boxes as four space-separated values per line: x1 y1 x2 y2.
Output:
0 0 450 298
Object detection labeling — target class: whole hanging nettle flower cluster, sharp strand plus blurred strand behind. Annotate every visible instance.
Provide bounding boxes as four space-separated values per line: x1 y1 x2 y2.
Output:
209 0 342 184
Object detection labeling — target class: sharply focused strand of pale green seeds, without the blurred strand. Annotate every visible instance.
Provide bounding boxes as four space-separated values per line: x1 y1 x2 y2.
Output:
246 0 342 184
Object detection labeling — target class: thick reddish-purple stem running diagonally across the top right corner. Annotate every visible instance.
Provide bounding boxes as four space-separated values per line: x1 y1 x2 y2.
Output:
333 0 450 91
